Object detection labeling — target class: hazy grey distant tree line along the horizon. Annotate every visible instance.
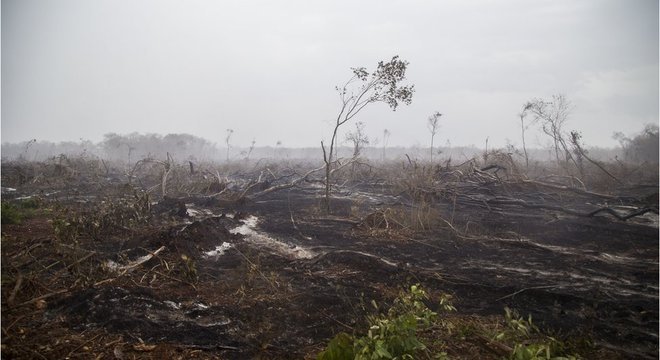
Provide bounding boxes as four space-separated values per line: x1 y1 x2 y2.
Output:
1 125 659 164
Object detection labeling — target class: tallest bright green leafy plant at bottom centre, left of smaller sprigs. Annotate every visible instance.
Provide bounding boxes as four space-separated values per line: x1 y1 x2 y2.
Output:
317 285 454 360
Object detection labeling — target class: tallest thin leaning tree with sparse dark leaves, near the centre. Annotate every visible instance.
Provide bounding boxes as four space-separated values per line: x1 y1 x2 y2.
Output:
321 56 414 212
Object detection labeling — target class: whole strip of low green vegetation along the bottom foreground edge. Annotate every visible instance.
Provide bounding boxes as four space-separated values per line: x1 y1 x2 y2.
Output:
317 285 593 360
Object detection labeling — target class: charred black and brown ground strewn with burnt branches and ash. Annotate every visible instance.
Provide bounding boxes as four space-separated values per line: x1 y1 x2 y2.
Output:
2 162 659 359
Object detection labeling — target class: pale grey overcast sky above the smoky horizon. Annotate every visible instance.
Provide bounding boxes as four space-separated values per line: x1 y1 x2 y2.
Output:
1 0 658 147
